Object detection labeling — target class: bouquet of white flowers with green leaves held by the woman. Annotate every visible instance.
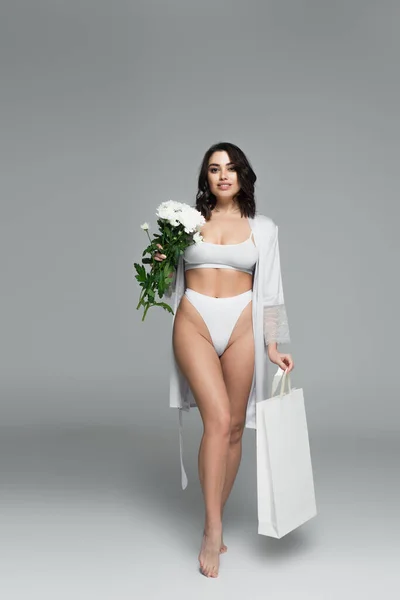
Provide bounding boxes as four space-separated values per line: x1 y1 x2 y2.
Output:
133 200 206 321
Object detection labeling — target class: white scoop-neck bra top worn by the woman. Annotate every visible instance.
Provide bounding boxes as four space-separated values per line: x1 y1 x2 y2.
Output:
183 231 258 275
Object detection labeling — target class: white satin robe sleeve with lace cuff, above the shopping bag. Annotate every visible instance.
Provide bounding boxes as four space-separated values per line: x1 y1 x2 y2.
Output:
263 223 290 346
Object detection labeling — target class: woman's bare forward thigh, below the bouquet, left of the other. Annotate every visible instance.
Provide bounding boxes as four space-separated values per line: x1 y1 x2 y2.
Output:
172 296 230 430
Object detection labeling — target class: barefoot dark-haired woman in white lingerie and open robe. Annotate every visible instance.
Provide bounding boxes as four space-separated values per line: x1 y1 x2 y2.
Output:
155 143 294 577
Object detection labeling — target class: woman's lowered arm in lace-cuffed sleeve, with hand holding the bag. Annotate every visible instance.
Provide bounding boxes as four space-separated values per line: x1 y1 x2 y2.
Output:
263 223 294 372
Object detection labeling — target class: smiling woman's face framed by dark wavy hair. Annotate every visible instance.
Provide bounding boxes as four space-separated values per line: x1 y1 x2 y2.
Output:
207 150 240 200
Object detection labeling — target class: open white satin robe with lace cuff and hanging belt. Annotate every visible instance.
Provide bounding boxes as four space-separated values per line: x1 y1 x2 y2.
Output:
167 215 290 489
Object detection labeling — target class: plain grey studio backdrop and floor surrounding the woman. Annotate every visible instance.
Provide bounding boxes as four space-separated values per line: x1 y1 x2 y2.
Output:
0 0 400 600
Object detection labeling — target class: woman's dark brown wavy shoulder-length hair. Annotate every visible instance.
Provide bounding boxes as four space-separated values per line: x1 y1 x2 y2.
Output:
196 142 257 221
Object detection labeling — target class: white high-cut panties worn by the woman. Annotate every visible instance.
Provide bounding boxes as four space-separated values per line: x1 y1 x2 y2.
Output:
185 288 253 356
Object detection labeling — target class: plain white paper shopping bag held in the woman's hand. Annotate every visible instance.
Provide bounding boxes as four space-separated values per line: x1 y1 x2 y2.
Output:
256 368 317 538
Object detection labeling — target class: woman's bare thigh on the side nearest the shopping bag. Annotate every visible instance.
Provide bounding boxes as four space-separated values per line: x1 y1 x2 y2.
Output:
220 301 255 430
